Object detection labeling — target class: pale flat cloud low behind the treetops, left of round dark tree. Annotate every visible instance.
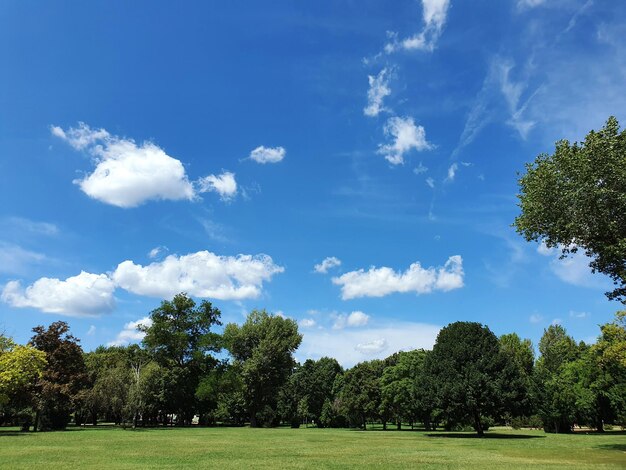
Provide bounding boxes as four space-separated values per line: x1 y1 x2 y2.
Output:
296 322 440 367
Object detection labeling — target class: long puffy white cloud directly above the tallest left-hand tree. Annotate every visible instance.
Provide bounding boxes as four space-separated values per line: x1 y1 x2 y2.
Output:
112 251 284 300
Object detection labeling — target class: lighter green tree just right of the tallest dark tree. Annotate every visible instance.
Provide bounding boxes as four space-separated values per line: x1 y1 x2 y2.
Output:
224 310 302 427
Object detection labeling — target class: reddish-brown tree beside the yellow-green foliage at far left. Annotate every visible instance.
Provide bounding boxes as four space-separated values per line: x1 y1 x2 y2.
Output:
31 321 88 430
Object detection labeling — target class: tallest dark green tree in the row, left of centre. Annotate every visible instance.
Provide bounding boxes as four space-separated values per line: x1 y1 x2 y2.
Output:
139 293 221 424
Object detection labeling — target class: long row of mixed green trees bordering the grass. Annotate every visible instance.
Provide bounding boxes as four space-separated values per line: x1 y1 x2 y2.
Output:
0 293 626 435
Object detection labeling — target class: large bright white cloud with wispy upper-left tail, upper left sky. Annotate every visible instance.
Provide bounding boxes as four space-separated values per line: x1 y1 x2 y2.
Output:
52 123 195 208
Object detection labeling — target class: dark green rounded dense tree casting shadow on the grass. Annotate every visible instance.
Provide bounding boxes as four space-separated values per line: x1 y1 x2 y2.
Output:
427 322 514 436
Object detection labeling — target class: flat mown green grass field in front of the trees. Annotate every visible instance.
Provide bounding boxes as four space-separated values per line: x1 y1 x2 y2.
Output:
0 427 626 470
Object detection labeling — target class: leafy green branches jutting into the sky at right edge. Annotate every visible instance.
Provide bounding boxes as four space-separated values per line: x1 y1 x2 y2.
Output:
514 117 626 303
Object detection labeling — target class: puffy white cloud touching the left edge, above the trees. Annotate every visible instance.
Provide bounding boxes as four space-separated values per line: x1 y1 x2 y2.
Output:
0 271 115 317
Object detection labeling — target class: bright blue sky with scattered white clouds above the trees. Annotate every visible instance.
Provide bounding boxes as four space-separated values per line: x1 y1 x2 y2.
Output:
0 0 626 365
